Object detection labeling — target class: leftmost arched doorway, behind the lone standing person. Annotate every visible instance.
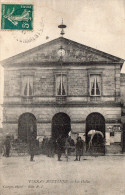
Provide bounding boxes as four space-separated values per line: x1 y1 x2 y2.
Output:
18 113 37 142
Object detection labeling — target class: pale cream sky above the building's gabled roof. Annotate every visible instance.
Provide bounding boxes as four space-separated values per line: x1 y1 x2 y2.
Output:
0 0 125 125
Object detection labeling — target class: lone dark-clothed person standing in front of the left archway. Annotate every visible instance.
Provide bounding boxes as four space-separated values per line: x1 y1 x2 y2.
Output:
29 133 36 161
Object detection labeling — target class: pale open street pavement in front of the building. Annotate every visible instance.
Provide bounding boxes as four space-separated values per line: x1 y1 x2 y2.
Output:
0 155 125 195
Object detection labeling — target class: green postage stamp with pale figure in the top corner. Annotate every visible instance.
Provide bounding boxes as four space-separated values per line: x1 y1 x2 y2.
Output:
1 4 33 30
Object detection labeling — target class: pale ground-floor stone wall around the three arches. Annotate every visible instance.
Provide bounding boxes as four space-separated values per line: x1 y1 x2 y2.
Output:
3 106 121 136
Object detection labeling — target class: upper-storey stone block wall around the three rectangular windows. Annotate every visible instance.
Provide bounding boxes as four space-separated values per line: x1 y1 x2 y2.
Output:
4 65 120 102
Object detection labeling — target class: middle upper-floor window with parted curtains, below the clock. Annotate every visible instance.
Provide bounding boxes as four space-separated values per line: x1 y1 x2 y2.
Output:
56 74 67 96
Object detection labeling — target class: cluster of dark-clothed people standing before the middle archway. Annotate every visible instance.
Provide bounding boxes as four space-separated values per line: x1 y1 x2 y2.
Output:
42 136 84 161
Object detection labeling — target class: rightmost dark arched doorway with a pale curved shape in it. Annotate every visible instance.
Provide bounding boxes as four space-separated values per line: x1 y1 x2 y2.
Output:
86 112 105 153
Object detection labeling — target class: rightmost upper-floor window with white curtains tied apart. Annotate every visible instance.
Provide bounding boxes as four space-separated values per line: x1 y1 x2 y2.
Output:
90 74 101 96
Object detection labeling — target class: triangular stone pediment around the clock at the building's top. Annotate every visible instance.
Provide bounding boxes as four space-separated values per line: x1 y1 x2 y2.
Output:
3 37 121 65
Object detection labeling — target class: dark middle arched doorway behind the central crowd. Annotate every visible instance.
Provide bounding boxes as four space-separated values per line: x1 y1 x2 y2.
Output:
52 112 71 139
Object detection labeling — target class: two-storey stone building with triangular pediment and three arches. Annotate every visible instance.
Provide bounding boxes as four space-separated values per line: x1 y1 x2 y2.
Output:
2 37 124 153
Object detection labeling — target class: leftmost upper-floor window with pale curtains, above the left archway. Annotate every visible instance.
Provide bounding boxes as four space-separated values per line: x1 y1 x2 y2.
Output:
22 76 33 97
